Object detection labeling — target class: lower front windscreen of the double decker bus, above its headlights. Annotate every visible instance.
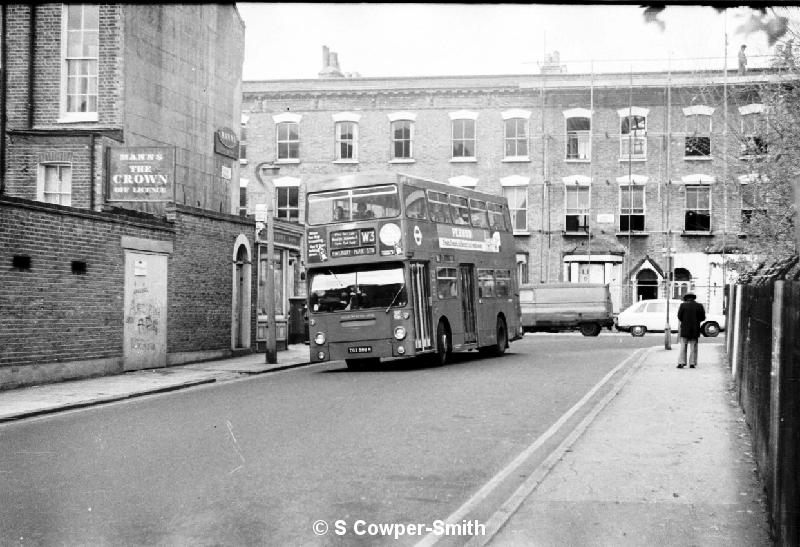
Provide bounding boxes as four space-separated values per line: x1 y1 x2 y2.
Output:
309 264 408 312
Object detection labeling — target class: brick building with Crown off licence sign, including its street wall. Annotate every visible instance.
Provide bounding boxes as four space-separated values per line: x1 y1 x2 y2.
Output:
0 4 256 389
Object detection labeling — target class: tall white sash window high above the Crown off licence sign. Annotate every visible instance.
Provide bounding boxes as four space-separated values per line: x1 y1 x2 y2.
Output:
58 4 100 123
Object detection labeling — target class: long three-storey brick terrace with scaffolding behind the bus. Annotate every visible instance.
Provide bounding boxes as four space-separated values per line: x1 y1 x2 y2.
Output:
241 49 772 311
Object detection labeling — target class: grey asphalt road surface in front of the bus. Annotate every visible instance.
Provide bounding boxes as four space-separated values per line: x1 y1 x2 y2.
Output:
0 332 720 545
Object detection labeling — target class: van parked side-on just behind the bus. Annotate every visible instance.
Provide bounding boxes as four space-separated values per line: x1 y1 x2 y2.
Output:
519 283 614 336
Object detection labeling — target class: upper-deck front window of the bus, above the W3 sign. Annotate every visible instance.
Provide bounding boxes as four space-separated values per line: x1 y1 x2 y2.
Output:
308 184 400 226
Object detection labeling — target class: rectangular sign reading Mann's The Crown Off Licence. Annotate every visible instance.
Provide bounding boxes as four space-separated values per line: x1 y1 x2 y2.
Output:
106 146 175 202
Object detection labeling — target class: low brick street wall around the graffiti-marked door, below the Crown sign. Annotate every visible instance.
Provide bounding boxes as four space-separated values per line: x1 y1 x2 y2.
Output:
0 198 256 386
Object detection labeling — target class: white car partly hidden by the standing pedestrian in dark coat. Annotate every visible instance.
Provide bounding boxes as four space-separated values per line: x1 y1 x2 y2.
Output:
616 298 725 336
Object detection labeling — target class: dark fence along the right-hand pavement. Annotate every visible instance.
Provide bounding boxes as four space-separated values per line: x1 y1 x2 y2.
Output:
726 261 800 546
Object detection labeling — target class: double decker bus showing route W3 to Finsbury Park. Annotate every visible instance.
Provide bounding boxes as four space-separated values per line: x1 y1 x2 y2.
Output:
306 173 523 369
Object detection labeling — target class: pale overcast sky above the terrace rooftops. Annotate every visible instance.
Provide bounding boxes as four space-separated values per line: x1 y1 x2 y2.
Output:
237 2 771 80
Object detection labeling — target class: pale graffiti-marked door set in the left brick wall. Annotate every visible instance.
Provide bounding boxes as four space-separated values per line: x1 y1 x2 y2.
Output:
122 251 167 370
